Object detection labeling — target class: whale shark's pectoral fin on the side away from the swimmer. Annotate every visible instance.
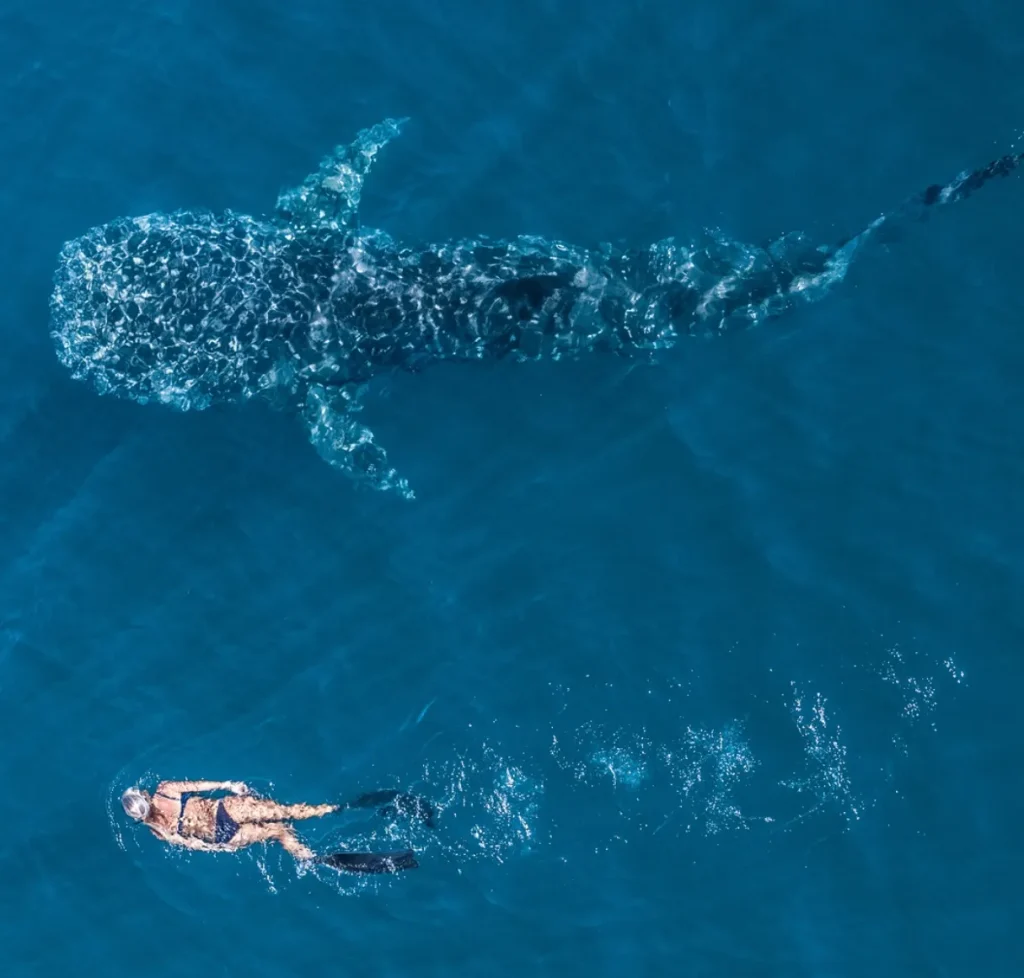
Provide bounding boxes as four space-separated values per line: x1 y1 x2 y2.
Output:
276 119 409 227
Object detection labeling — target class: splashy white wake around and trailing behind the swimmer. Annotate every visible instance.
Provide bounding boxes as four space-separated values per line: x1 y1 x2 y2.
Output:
106 645 964 895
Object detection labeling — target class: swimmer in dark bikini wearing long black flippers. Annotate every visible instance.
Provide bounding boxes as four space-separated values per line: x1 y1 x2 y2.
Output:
121 781 434 873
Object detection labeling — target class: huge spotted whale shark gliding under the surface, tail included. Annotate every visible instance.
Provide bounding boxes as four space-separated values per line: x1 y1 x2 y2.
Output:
50 119 1024 499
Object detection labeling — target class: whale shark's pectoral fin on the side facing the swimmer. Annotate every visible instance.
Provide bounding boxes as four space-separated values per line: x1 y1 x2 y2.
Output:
302 384 415 499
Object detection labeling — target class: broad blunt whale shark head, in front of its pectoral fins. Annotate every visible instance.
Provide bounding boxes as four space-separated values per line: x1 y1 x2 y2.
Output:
50 213 280 410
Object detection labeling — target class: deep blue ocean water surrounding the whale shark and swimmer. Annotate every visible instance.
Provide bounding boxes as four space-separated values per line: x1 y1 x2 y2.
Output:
0 0 1024 978
